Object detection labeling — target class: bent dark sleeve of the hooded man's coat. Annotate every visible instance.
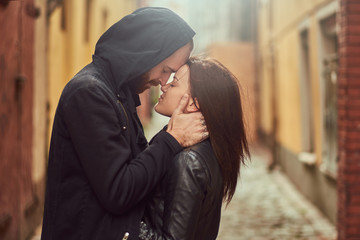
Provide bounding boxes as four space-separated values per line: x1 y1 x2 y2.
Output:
61 82 182 214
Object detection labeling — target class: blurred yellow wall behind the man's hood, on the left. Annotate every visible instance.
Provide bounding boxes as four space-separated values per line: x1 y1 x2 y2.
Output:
48 0 136 142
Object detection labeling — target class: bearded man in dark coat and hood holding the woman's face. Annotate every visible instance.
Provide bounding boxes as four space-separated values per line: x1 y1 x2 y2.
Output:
41 8 206 240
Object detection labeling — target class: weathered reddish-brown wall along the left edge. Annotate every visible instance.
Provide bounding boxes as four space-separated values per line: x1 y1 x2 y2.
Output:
0 0 42 240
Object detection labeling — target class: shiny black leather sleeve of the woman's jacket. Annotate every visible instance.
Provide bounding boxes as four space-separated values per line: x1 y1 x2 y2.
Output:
140 151 208 240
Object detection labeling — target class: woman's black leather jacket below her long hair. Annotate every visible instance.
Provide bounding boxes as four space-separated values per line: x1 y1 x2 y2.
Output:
140 140 223 240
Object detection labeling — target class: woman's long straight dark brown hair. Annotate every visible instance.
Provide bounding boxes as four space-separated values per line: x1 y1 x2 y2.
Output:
187 57 250 204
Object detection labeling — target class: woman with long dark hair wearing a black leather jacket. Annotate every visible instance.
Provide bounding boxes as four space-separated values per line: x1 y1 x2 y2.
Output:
140 57 250 240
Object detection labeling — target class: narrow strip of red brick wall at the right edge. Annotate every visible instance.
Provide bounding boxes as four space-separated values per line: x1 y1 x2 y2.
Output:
338 0 360 239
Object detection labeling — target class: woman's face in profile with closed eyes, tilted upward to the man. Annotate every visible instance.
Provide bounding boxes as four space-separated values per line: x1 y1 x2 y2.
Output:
155 64 191 117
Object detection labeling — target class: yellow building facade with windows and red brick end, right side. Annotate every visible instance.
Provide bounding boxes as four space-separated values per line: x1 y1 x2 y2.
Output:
257 0 360 239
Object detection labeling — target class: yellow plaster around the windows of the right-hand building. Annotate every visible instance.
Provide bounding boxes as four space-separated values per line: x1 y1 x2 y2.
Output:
258 0 334 162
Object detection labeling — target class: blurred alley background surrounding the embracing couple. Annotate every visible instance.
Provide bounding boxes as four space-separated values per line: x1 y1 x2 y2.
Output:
0 0 360 240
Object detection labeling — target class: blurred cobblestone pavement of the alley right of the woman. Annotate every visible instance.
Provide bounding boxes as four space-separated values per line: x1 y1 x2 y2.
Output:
218 149 337 240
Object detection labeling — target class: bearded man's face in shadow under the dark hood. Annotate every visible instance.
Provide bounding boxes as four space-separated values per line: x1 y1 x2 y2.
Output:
137 43 192 93
